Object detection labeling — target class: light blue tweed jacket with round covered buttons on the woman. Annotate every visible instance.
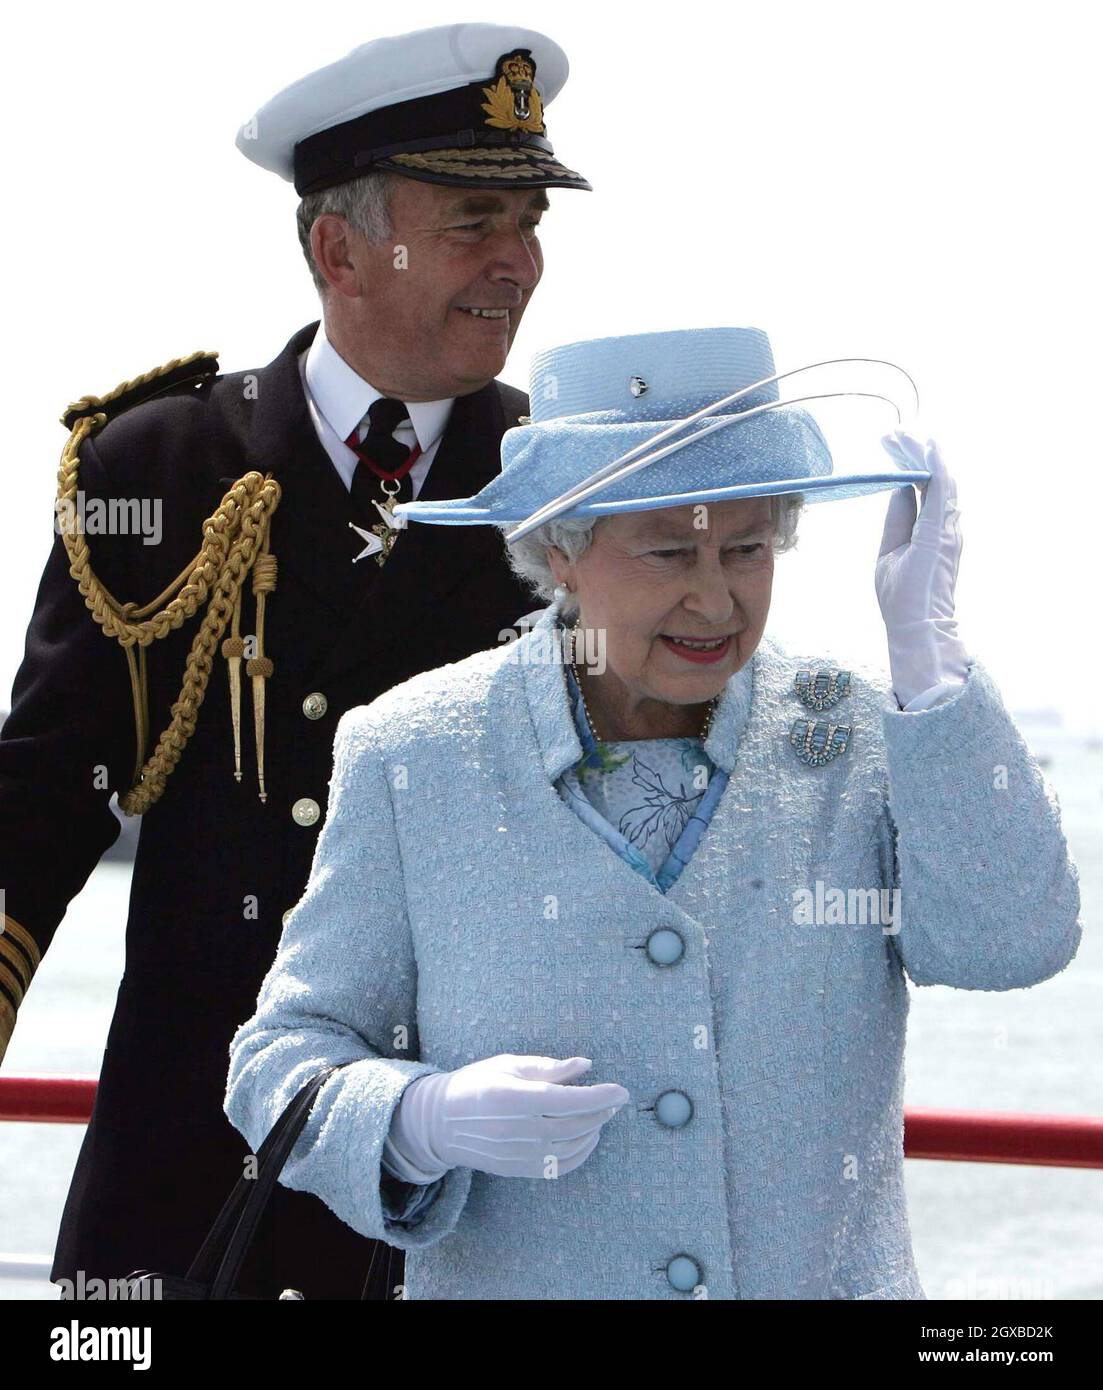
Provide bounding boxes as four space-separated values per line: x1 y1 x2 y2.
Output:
225 607 1081 1300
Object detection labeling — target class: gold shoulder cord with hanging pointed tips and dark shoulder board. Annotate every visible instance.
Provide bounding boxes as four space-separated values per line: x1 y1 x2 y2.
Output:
56 353 281 816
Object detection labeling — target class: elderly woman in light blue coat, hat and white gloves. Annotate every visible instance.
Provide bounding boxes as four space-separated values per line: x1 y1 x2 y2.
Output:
225 329 1081 1300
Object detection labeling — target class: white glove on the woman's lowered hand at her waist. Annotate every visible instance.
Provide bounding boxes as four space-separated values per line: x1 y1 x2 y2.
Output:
388 1052 629 1182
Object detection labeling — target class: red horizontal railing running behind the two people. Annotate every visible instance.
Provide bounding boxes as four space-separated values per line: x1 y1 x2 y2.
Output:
0 1076 1103 1168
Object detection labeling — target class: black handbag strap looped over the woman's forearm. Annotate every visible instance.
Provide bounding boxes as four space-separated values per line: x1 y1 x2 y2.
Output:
186 1063 347 1298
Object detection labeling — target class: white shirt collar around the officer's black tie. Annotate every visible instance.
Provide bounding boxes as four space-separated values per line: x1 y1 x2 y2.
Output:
299 322 454 498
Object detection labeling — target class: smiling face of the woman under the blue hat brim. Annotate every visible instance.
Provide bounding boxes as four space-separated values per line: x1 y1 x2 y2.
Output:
549 498 774 714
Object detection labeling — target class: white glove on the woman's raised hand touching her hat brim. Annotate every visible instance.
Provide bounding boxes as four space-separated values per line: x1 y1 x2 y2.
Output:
874 430 972 709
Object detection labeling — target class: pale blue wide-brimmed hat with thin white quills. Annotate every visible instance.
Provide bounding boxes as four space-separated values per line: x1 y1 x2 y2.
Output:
395 328 929 530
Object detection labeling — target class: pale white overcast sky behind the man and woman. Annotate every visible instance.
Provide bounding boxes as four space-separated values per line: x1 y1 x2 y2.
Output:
0 0 1103 728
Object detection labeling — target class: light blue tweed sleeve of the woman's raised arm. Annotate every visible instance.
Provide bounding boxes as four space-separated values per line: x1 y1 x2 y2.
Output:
881 662 1081 990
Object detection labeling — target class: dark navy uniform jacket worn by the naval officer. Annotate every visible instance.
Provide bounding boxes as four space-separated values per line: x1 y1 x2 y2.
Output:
0 324 533 1298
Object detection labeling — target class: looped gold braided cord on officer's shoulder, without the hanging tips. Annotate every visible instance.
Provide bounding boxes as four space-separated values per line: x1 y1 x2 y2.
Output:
57 353 281 816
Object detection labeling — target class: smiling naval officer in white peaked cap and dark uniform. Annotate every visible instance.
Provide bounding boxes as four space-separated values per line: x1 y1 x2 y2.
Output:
0 24 589 1298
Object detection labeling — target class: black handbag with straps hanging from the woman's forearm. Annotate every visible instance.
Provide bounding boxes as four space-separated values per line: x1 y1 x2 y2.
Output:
126 1066 392 1301
